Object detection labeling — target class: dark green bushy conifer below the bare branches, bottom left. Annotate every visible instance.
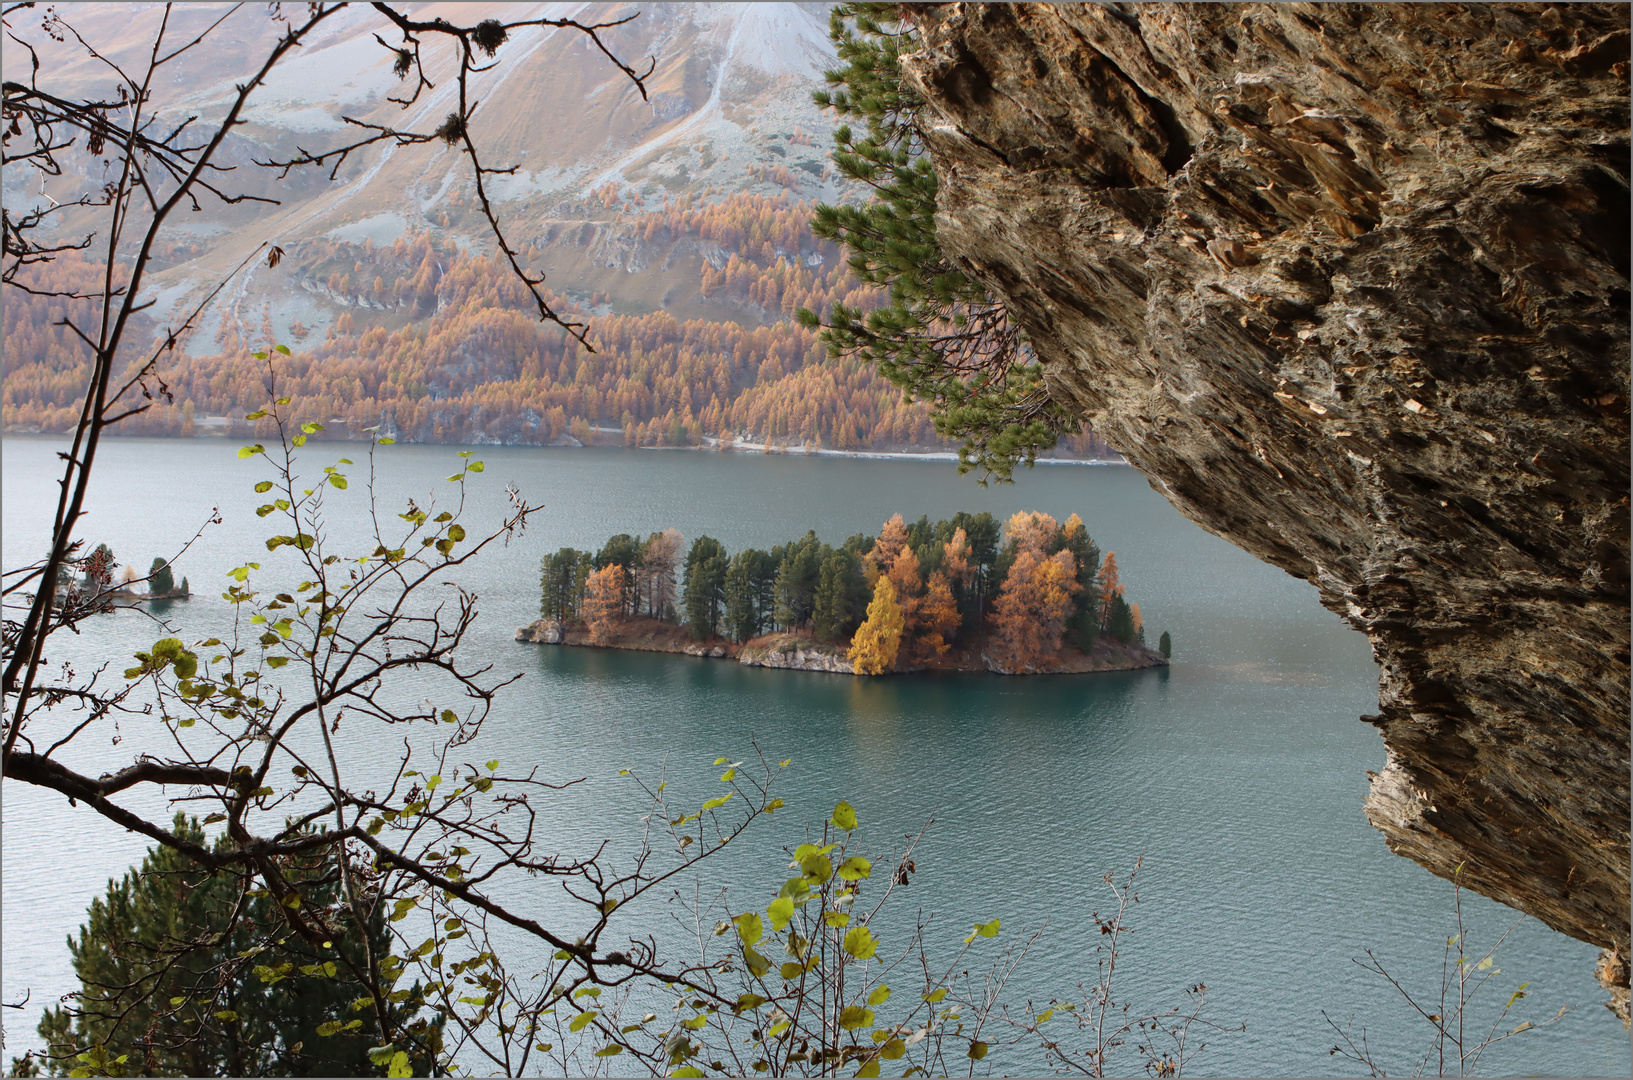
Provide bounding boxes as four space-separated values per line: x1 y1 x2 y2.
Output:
39 814 441 1077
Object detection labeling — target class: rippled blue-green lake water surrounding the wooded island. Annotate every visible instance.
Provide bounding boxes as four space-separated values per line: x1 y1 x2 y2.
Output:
0 436 1630 1075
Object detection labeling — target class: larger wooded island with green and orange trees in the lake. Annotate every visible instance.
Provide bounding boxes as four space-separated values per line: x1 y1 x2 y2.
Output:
516 511 1171 675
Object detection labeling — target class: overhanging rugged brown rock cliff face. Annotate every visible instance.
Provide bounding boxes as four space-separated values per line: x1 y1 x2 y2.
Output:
906 3 1630 1010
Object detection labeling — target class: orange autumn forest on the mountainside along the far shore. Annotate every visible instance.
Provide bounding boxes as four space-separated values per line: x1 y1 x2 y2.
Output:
0 188 1109 456
